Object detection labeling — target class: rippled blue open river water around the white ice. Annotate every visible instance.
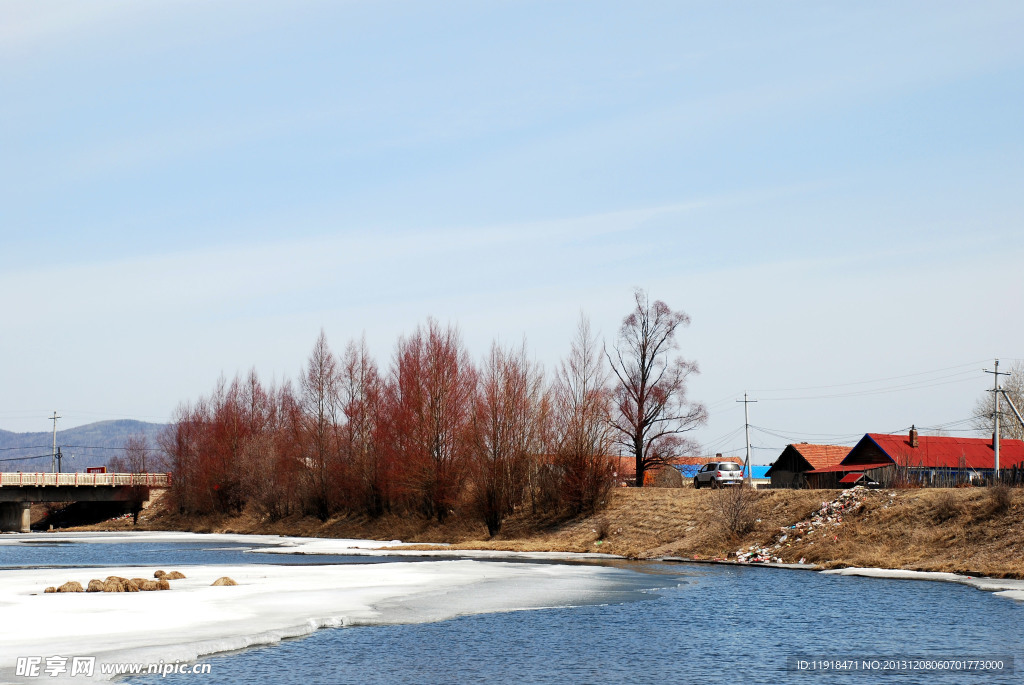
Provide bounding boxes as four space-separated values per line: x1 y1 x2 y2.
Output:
0 542 1024 685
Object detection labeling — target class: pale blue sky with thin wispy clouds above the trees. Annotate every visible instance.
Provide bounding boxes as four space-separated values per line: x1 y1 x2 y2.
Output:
0 0 1024 461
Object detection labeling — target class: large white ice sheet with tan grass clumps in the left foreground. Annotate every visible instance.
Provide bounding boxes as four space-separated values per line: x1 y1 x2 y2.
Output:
0 559 643 683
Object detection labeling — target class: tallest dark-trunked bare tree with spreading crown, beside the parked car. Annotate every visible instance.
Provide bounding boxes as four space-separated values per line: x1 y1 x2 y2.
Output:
605 289 708 487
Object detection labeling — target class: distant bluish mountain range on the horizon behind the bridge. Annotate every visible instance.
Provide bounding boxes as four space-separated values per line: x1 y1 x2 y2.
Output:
0 420 167 472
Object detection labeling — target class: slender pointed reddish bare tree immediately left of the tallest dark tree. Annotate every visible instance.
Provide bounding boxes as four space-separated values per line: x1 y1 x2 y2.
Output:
549 315 612 514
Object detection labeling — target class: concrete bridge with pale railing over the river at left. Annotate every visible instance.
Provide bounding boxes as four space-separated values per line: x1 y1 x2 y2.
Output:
0 473 171 532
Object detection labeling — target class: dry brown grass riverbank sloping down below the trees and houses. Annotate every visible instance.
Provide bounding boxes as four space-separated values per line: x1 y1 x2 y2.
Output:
72 488 1024 577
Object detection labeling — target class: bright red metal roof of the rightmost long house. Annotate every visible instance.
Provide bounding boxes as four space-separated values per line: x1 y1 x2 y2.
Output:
860 433 1024 469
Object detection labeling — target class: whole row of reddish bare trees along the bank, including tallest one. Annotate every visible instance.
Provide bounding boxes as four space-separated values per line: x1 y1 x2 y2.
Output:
160 291 706 534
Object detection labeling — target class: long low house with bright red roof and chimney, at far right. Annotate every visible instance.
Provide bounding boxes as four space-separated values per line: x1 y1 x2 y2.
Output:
805 427 1024 487
